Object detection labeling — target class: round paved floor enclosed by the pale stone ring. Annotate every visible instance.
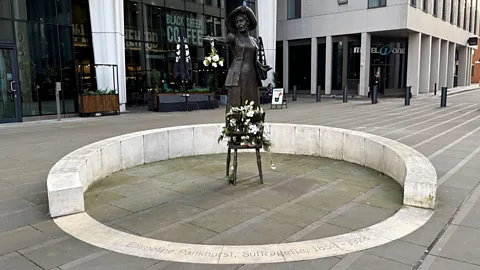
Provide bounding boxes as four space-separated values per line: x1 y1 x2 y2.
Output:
85 153 403 245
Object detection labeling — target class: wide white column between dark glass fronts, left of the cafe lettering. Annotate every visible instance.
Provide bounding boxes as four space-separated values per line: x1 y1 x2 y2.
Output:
88 0 127 112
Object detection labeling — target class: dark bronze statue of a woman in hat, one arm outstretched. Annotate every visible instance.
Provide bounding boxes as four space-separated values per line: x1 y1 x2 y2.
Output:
204 6 272 108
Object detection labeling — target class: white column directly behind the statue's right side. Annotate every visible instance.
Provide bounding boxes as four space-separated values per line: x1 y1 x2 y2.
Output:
257 0 277 85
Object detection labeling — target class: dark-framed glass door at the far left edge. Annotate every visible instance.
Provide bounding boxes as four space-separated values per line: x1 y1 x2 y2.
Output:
0 44 22 123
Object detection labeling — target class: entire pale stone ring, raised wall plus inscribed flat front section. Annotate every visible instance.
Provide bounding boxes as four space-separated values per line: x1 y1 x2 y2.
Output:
47 123 437 263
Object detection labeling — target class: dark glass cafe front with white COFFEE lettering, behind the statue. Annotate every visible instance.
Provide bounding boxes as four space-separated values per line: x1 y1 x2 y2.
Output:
119 0 227 105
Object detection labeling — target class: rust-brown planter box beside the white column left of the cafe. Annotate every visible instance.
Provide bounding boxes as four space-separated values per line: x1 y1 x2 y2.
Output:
78 95 120 114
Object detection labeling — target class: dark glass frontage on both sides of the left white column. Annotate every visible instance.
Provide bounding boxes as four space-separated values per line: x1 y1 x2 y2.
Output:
0 0 229 122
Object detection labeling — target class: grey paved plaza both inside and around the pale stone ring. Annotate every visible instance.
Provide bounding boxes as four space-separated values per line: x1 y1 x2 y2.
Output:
0 91 480 270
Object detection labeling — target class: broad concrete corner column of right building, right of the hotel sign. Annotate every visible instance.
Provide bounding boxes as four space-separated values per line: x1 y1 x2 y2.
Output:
407 33 422 95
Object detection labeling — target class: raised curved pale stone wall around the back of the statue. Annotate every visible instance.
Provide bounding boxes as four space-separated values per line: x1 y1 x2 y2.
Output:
47 124 437 218
